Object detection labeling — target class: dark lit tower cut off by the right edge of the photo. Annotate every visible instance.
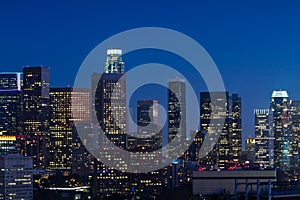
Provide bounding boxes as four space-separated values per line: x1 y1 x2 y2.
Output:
291 100 300 179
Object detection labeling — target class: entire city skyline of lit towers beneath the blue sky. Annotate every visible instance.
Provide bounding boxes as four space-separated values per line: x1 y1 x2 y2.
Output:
0 49 300 199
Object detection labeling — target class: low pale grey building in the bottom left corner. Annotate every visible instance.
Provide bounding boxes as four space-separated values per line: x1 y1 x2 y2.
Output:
0 154 33 200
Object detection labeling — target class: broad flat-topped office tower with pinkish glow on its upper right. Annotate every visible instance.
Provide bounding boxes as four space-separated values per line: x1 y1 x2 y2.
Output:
48 88 90 171
